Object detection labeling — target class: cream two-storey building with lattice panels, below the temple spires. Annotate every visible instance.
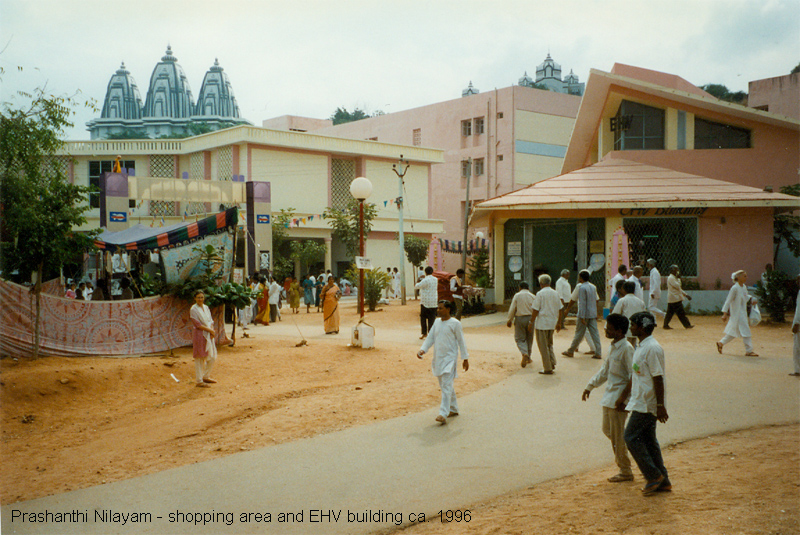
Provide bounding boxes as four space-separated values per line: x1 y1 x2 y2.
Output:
59 126 443 285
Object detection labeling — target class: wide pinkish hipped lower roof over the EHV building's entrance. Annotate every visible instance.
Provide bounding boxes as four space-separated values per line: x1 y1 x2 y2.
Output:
475 158 800 212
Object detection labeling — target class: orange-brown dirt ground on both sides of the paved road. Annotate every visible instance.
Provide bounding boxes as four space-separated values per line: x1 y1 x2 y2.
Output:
0 301 800 534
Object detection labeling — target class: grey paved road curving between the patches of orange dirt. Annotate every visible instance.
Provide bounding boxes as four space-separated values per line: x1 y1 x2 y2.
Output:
2 314 800 534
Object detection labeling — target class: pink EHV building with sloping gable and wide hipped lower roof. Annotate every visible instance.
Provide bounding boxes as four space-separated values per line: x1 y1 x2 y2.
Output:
473 64 800 303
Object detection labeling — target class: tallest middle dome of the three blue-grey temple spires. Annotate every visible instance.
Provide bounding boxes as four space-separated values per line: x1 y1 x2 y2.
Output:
143 46 194 119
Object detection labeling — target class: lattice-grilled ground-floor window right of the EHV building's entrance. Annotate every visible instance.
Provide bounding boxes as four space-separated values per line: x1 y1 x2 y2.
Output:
622 217 697 277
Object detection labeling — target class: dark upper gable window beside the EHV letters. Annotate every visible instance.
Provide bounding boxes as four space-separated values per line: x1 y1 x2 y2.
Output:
611 100 664 150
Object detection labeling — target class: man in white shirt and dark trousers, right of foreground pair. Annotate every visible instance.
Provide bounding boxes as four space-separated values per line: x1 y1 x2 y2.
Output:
617 312 672 496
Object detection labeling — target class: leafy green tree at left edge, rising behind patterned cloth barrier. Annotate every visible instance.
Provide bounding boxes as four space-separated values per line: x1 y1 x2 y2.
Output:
0 88 98 358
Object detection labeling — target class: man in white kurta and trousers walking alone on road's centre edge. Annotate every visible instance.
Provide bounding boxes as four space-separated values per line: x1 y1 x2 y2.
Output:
417 301 469 425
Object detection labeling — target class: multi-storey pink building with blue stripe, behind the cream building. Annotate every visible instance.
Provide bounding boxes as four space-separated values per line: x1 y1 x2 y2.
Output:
263 86 581 271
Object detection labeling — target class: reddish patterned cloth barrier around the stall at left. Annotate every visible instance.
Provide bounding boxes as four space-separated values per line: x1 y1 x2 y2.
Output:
0 279 230 357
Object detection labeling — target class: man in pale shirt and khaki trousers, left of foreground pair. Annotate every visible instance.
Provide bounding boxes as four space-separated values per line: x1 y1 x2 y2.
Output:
581 314 633 483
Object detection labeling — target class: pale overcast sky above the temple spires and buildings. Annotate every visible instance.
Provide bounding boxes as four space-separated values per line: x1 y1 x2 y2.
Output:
0 0 800 139
